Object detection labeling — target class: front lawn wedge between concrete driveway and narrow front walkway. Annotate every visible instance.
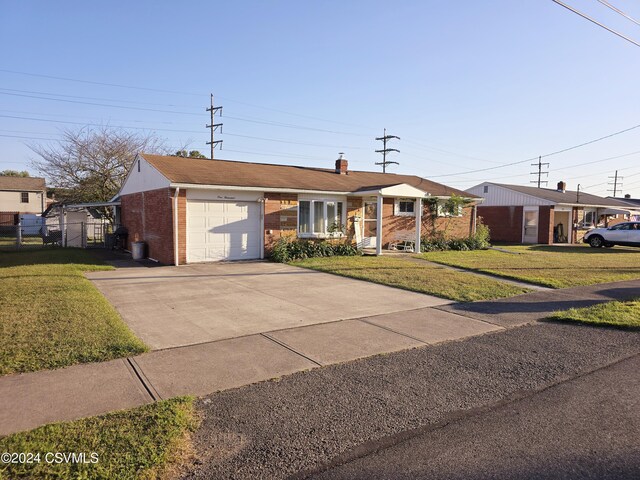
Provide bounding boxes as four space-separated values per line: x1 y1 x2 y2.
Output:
291 256 528 302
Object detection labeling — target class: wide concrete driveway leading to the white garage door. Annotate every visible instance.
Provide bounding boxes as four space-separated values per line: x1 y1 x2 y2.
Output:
87 262 450 349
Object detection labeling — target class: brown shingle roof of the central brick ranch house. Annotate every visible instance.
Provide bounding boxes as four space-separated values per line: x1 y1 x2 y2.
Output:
142 154 475 198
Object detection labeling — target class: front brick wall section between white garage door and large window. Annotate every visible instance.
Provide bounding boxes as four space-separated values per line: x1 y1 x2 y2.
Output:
264 192 298 255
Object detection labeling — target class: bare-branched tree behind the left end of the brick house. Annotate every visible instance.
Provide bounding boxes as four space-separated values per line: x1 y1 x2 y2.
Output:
30 126 166 202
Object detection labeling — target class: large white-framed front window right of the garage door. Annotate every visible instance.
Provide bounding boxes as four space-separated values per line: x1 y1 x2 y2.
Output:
298 200 344 237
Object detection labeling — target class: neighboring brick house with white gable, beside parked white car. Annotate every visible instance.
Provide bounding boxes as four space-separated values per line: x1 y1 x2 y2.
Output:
467 182 636 244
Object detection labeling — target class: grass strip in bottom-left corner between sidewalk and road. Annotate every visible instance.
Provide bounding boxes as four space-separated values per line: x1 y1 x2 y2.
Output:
0 398 198 480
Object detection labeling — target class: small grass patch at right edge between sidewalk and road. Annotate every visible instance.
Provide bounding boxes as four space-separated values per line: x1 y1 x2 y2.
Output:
549 299 640 329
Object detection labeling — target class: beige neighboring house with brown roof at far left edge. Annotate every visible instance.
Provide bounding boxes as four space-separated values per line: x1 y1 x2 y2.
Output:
0 175 47 225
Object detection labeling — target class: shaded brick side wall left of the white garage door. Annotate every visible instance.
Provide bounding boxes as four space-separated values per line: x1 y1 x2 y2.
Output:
120 188 175 264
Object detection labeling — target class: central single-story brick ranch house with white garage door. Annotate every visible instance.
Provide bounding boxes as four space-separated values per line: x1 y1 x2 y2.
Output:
116 154 479 264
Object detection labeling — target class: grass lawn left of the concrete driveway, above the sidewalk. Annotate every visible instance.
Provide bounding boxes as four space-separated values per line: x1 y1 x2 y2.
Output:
0 248 147 375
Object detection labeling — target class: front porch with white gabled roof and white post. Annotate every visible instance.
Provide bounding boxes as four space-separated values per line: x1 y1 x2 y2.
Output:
350 184 430 255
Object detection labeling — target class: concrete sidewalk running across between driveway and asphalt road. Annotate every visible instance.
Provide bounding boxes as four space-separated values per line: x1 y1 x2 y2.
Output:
0 280 640 435
